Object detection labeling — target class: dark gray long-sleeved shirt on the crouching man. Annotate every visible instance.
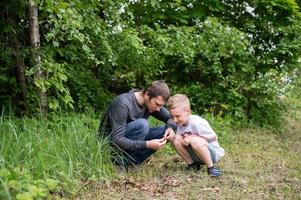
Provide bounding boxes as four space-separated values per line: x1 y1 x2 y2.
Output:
100 90 176 150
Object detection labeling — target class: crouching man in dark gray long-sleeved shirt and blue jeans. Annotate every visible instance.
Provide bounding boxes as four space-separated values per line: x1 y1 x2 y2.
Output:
99 81 176 167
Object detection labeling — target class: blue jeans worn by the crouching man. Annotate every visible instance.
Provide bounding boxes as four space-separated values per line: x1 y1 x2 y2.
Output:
116 118 166 164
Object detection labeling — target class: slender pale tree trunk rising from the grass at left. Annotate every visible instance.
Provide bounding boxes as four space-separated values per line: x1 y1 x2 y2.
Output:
29 1 48 114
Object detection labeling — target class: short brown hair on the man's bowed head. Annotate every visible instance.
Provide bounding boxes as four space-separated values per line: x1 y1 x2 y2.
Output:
143 80 170 102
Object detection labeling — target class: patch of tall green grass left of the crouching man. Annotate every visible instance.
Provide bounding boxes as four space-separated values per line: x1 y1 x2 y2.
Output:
0 113 113 198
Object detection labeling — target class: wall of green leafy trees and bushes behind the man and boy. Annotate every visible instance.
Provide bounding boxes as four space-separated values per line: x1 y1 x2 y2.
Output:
0 0 301 125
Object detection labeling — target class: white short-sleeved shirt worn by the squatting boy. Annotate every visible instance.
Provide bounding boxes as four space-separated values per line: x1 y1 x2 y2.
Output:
176 115 225 157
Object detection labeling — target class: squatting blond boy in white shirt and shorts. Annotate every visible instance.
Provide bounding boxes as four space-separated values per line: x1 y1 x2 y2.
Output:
167 94 224 177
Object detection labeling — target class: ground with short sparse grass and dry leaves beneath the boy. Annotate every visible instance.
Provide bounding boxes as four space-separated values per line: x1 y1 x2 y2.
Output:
75 102 301 200
